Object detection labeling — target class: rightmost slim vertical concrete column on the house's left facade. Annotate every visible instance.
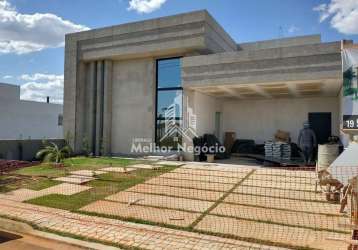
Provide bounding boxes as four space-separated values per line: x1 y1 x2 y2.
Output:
102 60 113 155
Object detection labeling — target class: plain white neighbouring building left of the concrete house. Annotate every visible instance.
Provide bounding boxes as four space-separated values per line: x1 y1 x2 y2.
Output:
0 83 63 140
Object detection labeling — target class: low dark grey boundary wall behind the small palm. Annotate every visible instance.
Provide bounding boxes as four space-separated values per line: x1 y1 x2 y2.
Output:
0 139 65 161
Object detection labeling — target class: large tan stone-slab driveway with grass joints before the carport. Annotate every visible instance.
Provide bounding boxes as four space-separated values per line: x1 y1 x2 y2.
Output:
81 164 350 249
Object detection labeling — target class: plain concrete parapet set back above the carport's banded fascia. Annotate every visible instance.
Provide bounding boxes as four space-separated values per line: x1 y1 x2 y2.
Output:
237 34 321 50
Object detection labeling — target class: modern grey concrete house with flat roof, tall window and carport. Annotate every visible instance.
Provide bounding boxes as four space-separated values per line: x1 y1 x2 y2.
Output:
64 11 342 158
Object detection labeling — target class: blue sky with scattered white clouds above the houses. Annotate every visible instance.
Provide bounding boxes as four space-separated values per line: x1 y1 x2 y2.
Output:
0 0 358 102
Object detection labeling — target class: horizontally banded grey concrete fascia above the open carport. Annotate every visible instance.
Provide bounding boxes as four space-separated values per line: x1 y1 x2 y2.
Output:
182 42 342 87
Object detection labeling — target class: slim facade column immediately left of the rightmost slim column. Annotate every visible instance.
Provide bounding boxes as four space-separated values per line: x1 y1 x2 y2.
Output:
95 61 104 155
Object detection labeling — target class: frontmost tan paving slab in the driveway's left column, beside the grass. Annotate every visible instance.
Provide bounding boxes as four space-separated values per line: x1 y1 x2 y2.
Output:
81 201 200 226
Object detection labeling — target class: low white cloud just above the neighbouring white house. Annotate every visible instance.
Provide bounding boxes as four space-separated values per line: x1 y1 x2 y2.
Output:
19 73 63 103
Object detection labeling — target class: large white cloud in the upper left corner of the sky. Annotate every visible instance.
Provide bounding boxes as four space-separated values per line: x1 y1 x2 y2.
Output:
0 0 88 54
